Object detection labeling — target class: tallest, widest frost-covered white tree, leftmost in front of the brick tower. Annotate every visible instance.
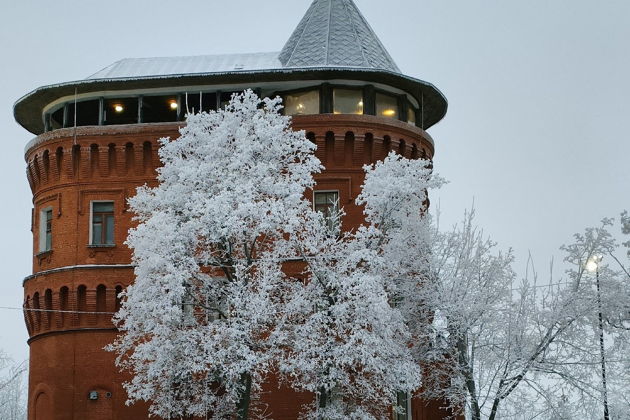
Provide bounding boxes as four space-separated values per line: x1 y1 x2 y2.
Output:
111 91 320 418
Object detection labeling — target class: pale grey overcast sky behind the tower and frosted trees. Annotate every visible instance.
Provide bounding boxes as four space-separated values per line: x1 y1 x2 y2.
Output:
0 0 630 359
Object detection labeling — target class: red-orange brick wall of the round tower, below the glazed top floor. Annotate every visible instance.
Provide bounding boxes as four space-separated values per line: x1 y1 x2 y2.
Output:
24 115 450 420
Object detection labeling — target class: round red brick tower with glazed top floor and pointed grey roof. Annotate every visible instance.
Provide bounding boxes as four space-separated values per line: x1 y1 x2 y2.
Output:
14 0 446 420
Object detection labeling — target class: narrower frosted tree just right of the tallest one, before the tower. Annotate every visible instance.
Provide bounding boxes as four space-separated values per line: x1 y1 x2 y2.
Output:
281 153 441 420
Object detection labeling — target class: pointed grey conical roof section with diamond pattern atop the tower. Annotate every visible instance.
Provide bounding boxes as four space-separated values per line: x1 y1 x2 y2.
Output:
279 0 400 73
